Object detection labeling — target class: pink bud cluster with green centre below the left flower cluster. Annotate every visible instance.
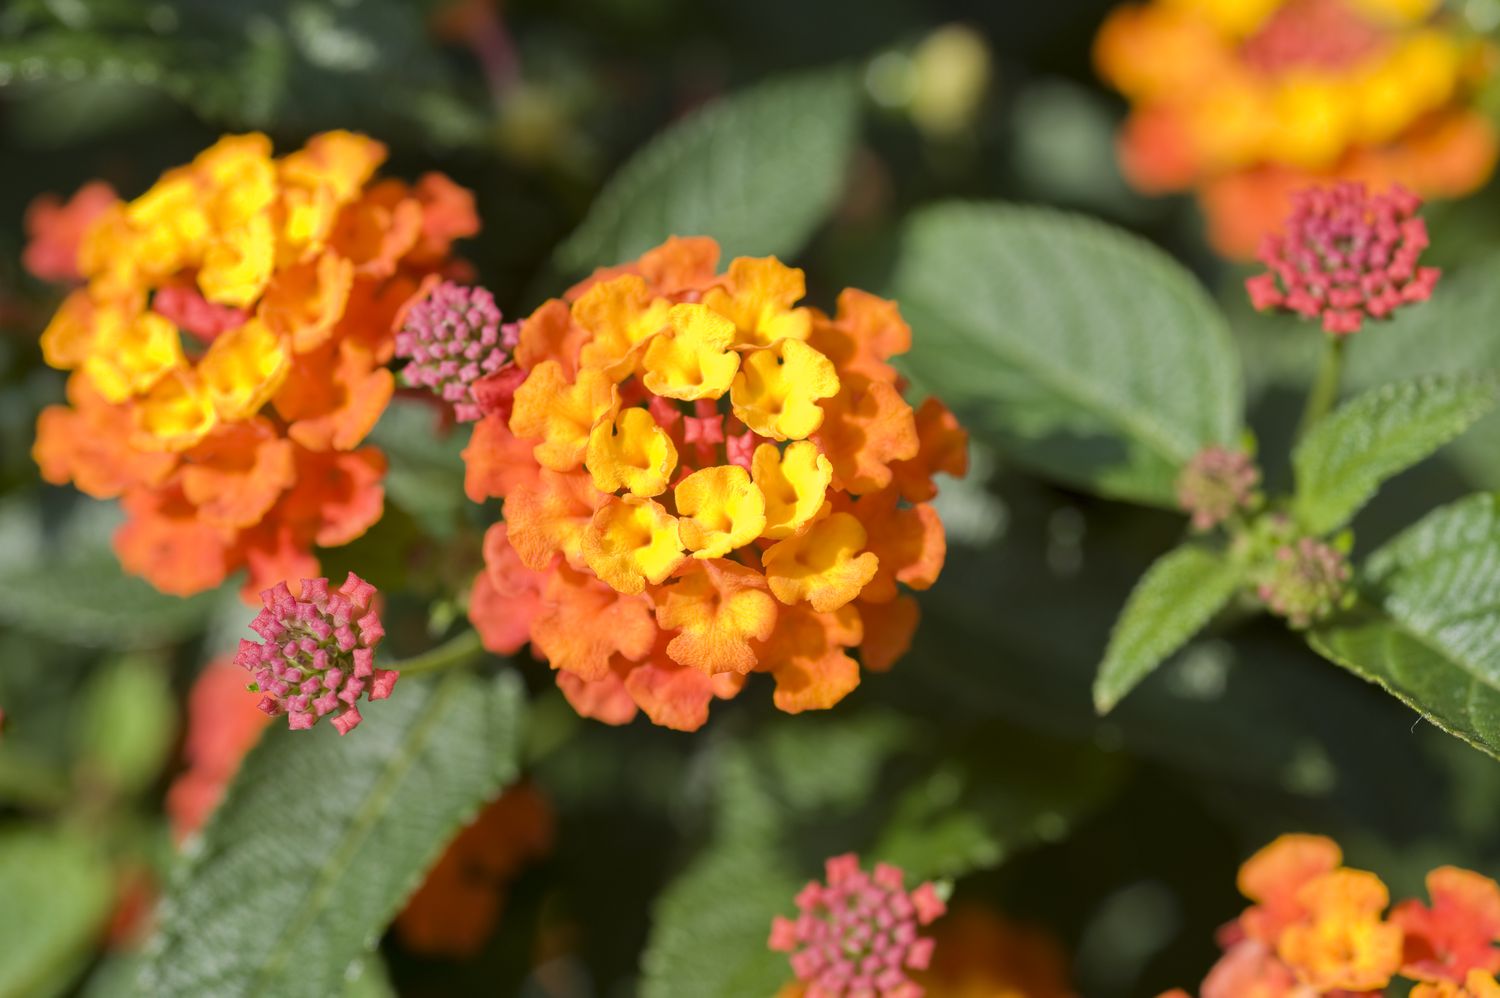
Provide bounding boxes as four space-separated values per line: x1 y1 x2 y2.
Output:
234 572 399 735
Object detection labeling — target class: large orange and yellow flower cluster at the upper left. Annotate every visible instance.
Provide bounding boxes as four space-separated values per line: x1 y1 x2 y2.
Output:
35 132 479 594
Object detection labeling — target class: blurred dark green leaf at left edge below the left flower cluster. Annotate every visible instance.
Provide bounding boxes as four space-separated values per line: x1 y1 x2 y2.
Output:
0 549 216 650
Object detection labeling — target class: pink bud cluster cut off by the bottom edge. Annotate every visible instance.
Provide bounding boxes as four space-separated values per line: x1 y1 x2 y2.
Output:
771 852 947 998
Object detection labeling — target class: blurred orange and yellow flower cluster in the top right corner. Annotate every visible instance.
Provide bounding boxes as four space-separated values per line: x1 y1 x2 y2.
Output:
1095 0 1497 257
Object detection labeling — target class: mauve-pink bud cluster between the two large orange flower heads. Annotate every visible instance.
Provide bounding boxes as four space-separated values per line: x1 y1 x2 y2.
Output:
396 281 521 423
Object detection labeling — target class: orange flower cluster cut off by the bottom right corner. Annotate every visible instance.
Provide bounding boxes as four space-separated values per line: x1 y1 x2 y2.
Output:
1163 834 1500 998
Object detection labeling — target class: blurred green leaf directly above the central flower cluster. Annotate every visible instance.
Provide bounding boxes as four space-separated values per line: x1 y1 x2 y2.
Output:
555 69 860 273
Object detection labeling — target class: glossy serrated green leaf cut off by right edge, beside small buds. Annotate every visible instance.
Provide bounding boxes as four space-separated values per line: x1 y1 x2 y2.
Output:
1308 494 1500 758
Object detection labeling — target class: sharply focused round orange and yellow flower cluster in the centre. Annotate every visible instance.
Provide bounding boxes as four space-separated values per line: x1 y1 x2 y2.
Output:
465 239 968 729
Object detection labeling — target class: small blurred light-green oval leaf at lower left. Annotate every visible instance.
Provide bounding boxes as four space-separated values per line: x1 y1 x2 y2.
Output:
75 659 177 794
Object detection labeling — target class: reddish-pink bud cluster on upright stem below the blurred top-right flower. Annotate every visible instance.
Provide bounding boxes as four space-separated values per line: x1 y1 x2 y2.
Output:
1245 183 1440 336
